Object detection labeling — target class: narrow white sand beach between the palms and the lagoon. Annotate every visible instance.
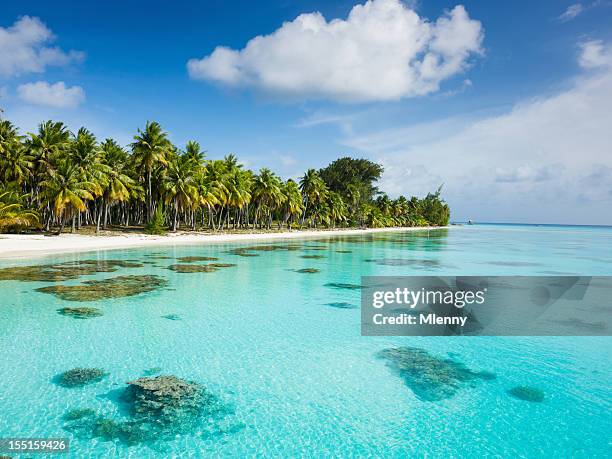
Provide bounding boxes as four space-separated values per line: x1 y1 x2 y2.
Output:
0 227 436 259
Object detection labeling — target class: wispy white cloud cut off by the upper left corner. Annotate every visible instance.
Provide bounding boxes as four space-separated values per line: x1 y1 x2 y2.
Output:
0 16 84 77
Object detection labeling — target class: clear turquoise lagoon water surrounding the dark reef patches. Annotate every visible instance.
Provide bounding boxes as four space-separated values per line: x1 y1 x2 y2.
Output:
0 225 612 458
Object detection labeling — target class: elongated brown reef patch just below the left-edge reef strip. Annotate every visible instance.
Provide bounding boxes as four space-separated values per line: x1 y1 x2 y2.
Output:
36 275 168 301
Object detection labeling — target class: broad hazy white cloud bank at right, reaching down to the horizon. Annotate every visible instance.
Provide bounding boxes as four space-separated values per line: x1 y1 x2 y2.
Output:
343 45 612 224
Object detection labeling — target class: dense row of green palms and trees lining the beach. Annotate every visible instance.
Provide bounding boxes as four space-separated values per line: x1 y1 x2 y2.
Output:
0 120 450 233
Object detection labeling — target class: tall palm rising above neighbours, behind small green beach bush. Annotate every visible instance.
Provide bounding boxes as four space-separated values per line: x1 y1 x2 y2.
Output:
131 121 173 220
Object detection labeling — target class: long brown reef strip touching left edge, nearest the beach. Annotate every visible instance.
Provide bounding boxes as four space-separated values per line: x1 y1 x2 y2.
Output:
0 260 144 282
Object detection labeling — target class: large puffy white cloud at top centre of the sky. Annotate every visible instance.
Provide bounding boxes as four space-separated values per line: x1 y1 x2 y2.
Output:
187 0 484 102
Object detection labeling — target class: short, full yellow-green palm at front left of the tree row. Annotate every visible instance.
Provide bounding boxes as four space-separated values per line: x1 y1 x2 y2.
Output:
40 160 96 234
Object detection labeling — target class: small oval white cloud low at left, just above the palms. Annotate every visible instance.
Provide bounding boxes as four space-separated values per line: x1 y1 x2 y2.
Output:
17 81 85 108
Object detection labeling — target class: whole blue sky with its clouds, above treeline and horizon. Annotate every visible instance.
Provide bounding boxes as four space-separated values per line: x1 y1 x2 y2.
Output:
0 0 612 224
